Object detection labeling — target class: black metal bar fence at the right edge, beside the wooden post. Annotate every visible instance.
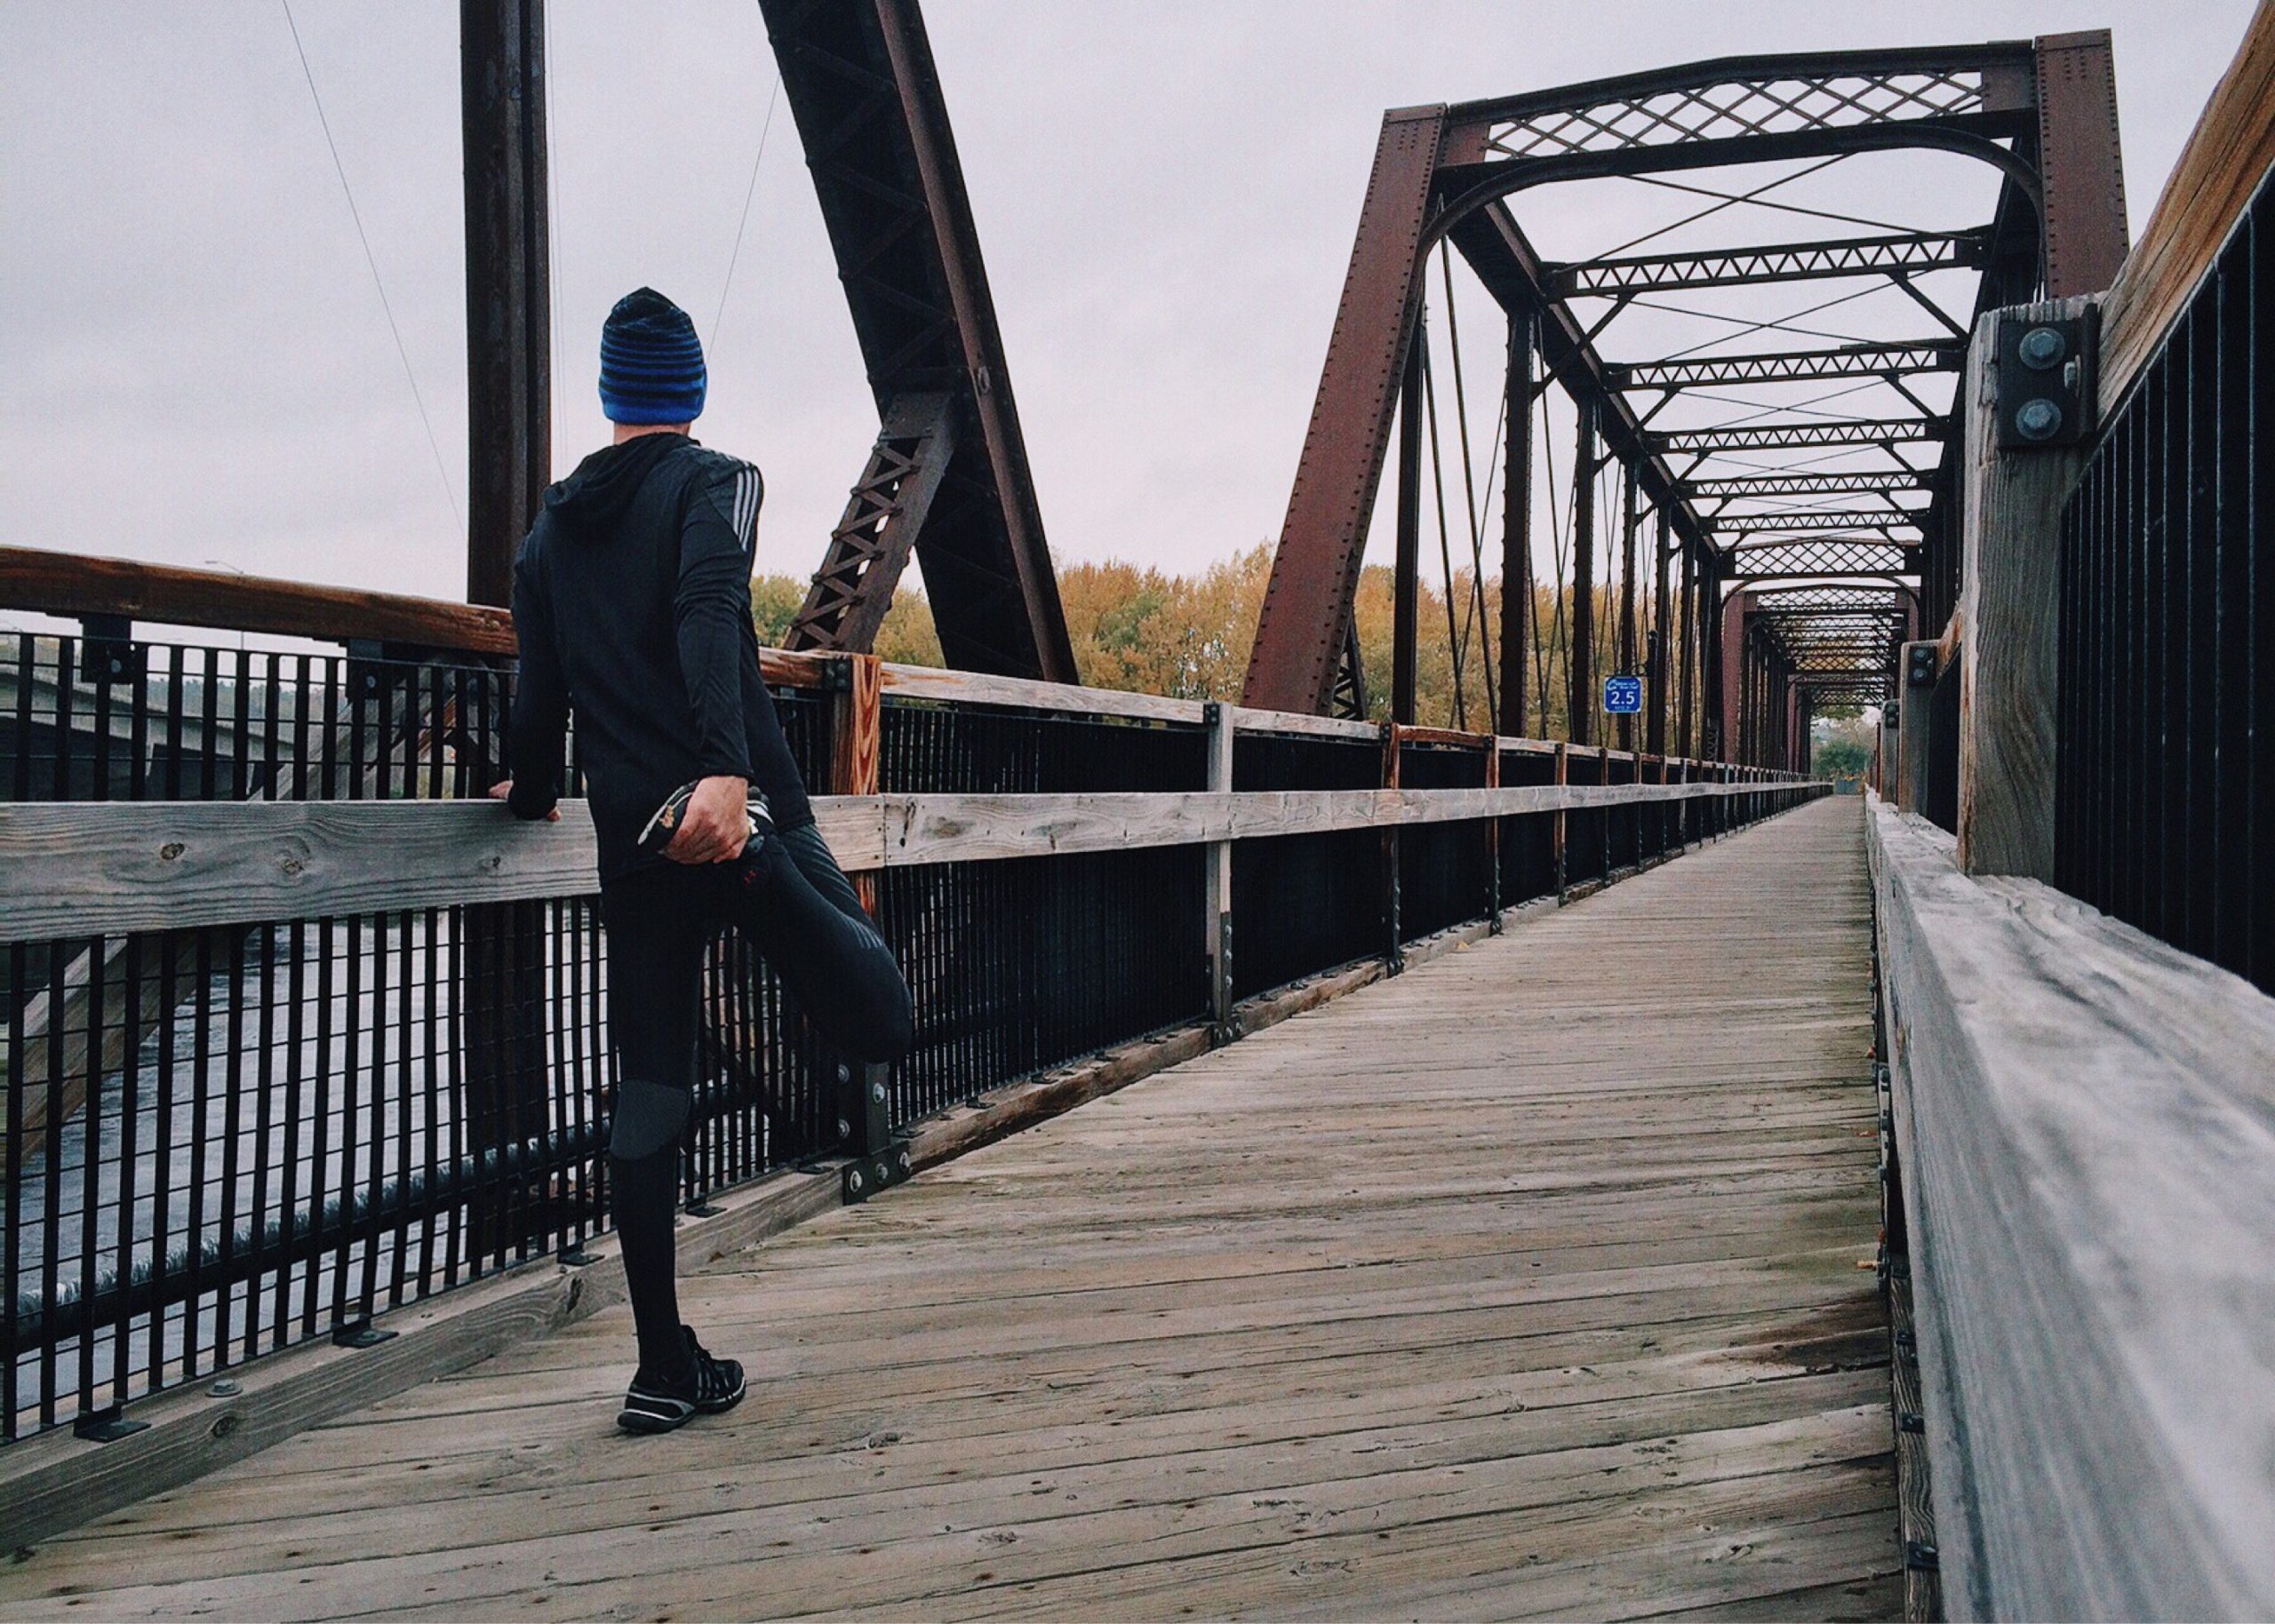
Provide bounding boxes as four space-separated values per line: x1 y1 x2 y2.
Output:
2055 171 2275 991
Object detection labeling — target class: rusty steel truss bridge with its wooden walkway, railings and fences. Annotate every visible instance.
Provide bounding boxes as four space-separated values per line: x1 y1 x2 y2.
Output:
0 0 2275 1620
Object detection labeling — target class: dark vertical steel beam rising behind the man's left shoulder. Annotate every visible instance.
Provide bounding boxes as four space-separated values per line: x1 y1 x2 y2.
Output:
458 0 553 608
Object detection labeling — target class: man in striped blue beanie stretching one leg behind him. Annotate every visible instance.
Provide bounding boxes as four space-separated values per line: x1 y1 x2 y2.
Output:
491 289 913 1433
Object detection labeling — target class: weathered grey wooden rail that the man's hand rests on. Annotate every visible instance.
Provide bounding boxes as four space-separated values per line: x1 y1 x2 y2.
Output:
0 778 1807 943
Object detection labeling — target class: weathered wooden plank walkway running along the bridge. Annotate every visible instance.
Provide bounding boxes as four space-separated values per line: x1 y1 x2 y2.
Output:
0 799 1902 1620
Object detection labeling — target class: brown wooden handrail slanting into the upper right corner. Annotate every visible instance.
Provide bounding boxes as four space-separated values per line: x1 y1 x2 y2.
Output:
2100 0 2275 421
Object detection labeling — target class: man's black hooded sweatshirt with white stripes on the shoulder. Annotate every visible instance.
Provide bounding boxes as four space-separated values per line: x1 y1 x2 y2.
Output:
509 434 814 882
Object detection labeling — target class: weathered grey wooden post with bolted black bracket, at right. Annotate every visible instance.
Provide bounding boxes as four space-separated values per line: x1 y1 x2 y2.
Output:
1956 298 2100 880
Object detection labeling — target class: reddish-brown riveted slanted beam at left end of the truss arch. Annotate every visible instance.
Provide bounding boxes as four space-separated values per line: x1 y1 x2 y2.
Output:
1242 107 1445 712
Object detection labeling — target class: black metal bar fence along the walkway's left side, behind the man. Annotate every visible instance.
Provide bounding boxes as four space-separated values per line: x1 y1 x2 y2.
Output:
0 637 1800 1437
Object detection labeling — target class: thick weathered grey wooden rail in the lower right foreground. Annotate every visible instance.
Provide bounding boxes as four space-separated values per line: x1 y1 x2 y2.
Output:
1865 796 2275 1617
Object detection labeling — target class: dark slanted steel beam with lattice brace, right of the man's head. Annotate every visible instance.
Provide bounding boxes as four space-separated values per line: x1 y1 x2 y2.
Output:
760 0 1078 682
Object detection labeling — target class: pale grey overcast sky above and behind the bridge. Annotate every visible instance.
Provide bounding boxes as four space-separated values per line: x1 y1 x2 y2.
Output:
0 0 2250 596
